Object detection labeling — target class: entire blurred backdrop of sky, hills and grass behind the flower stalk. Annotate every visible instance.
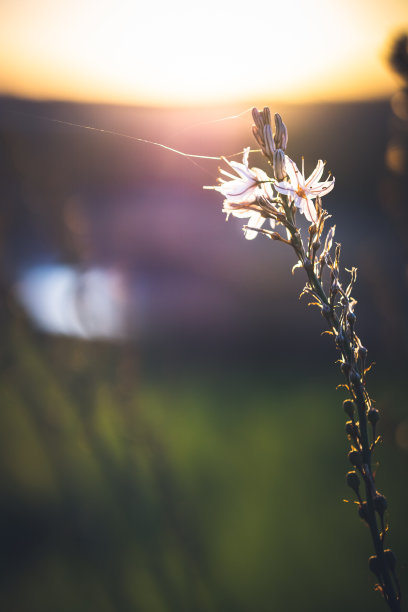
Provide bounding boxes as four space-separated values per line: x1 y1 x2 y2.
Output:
0 0 408 612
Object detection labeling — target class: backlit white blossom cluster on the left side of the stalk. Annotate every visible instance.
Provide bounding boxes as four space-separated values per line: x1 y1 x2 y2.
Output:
206 147 275 240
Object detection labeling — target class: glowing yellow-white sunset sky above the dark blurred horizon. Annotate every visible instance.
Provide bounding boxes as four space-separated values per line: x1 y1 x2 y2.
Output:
0 0 408 105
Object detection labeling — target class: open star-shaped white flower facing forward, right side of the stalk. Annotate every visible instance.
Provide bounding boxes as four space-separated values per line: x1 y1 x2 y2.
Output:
275 155 334 223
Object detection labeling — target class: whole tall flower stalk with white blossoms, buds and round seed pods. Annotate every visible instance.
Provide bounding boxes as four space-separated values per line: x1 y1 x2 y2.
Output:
206 108 401 612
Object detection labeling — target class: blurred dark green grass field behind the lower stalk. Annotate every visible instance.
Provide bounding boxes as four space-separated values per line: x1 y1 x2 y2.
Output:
0 306 408 612
